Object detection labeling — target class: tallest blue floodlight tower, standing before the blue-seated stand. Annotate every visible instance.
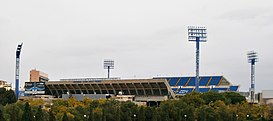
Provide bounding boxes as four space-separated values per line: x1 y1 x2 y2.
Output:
188 26 207 92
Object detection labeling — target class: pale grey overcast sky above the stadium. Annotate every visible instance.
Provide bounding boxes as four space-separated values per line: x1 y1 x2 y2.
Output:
0 0 273 91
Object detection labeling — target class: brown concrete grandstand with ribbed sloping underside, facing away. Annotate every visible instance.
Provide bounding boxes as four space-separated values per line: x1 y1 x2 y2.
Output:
45 78 175 101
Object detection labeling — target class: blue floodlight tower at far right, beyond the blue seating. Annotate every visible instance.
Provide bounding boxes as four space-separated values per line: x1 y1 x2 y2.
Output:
247 51 258 103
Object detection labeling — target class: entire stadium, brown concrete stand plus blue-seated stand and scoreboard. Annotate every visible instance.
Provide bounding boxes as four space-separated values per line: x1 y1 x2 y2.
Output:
25 73 239 102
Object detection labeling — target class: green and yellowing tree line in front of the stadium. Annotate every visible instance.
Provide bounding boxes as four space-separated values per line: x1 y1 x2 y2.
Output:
0 88 273 121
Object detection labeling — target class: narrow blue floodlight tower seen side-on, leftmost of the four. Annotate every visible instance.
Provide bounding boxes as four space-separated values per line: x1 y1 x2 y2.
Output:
15 43 23 99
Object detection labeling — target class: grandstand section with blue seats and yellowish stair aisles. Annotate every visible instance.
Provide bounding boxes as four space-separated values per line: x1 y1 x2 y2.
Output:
154 76 239 95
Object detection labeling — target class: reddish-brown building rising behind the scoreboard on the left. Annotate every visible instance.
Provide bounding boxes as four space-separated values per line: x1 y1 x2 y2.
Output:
30 69 49 82
